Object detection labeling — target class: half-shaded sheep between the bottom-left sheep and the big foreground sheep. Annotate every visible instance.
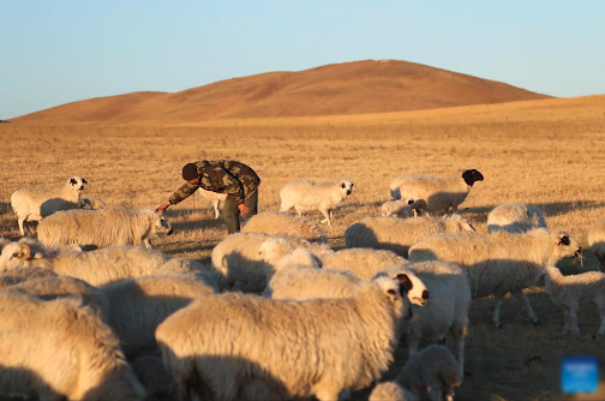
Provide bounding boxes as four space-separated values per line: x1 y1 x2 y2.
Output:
101 275 217 357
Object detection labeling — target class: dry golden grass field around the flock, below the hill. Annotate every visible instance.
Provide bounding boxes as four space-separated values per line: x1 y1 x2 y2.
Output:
0 96 605 401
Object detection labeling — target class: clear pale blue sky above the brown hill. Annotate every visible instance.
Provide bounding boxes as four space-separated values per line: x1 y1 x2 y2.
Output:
0 0 605 119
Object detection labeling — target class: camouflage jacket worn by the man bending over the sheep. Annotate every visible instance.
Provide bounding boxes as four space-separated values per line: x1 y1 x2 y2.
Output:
168 160 260 205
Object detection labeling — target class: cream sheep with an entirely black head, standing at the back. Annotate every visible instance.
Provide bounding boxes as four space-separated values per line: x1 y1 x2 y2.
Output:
390 169 483 213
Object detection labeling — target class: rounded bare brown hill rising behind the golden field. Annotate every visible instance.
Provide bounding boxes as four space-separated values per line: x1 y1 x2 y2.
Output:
16 60 548 122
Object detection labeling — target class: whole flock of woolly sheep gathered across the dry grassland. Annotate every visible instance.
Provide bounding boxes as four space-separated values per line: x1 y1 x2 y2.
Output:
0 170 605 401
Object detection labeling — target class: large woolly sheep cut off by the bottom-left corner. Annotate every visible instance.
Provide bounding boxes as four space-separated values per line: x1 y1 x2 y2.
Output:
0 291 145 401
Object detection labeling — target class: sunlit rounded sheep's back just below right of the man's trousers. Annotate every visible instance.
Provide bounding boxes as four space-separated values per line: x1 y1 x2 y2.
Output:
242 212 326 243
